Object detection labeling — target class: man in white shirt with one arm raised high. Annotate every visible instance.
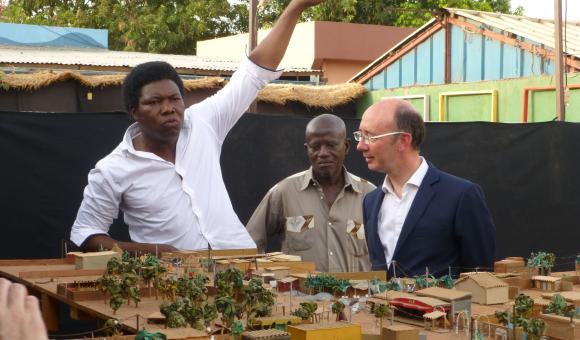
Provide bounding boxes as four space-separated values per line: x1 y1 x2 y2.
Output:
71 0 324 253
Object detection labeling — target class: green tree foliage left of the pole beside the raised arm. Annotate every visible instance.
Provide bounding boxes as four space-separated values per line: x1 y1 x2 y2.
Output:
3 0 242 54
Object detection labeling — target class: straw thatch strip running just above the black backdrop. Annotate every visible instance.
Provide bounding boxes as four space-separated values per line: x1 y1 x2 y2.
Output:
0 71 366 109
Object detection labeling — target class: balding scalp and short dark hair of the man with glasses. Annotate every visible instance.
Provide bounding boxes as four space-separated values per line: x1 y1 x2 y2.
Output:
363 98 425 150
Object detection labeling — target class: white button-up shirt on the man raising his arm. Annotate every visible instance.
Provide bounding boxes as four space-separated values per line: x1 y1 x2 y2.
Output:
71 59 281 250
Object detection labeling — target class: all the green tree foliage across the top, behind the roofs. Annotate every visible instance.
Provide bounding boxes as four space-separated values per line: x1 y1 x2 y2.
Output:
2 0 522 54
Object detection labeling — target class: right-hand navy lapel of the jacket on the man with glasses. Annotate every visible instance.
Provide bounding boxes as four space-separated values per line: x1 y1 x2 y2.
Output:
393 164 439 265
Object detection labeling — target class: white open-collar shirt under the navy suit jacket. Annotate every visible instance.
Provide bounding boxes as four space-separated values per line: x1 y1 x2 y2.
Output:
378 157 429 266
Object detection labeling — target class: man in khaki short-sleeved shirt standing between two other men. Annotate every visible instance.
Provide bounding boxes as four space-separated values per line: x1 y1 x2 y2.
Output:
247 114 375 272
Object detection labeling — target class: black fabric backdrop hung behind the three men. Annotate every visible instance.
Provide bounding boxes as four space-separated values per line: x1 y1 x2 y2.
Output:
0 112 580 270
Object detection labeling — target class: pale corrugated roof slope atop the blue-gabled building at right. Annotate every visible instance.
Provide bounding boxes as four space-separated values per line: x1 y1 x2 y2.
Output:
446 8 580 57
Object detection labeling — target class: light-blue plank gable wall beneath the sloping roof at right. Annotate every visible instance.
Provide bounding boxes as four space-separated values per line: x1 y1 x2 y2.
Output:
364 25 554 90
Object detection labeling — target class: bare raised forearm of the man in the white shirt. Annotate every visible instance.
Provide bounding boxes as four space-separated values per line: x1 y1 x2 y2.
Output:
250 0 325 70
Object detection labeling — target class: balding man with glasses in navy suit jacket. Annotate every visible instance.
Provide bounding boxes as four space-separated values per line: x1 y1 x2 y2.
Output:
354 99 495 277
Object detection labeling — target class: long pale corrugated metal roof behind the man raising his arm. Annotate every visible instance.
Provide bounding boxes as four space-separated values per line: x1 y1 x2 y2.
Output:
0 45 319 73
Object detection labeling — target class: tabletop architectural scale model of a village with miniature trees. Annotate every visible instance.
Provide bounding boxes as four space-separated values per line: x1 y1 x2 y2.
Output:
34 250 580 340
